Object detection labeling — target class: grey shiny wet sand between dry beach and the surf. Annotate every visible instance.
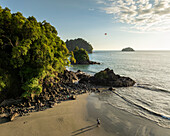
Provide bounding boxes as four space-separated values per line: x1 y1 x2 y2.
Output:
87 94 170 136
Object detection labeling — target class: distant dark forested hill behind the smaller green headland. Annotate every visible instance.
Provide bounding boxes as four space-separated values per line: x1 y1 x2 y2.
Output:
66 38 93 53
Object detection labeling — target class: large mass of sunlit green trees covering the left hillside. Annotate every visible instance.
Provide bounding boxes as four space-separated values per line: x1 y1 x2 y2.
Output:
0 6 70 97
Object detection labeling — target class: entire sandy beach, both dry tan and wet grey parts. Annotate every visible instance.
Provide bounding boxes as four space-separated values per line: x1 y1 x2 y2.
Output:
0 93 170 136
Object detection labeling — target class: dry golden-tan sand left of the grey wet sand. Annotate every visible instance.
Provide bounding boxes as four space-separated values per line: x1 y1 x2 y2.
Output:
0 94 105 136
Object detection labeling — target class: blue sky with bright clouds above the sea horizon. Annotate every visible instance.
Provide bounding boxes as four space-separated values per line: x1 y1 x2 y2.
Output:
0 0 170 50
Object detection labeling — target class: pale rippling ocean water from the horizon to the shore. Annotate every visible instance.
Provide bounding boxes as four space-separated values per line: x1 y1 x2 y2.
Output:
69 51 170 128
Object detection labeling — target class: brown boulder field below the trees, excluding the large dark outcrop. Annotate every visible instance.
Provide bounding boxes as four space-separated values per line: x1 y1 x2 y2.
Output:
0 70 96 121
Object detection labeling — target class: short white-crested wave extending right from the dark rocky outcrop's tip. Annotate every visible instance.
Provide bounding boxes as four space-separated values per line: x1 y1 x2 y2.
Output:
136 84 170 93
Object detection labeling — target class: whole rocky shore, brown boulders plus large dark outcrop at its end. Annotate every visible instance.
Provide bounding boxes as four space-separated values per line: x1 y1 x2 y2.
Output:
0 68 135 121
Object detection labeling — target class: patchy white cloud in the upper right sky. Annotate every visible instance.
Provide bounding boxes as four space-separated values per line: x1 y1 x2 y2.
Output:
97 0 170 32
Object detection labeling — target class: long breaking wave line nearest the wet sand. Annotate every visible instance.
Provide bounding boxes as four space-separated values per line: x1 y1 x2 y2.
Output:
112 91 170 120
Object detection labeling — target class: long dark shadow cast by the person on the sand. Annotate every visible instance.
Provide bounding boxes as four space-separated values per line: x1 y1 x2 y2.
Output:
72 124 97 136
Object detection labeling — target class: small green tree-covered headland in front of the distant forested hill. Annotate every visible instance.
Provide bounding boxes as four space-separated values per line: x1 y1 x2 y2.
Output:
74 48 89 64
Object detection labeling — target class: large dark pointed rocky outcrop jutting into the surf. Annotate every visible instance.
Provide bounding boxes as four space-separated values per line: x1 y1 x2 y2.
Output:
79 68 135 87
